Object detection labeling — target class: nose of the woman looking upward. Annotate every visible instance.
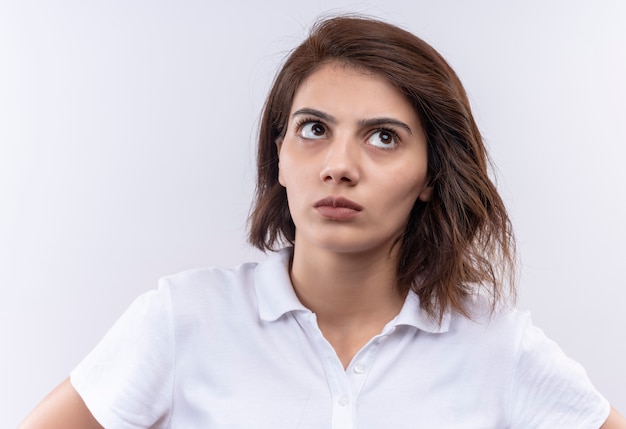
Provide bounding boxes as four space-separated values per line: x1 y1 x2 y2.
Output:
320 138 360 185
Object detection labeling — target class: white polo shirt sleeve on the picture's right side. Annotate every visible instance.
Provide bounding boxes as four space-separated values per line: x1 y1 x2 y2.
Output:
510 317 610 429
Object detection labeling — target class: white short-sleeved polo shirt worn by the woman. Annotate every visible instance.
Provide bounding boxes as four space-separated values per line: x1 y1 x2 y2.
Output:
71 249 609 429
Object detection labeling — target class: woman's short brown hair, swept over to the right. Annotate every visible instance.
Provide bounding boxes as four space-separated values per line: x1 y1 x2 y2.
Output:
249 16 515 321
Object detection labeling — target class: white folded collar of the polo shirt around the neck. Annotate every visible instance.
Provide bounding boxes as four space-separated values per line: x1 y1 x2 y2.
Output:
254 247 450 333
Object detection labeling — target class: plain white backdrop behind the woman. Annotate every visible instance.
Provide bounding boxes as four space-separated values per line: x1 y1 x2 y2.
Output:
0 0 626 427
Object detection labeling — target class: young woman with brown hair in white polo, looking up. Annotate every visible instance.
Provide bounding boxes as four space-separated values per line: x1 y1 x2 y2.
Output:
21 17 626 429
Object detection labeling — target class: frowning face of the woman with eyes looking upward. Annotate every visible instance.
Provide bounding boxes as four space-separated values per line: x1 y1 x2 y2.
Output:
277 64 432 252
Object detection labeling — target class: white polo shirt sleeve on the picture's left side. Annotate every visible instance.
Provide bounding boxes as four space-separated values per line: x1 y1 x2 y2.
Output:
70 279 174 429
